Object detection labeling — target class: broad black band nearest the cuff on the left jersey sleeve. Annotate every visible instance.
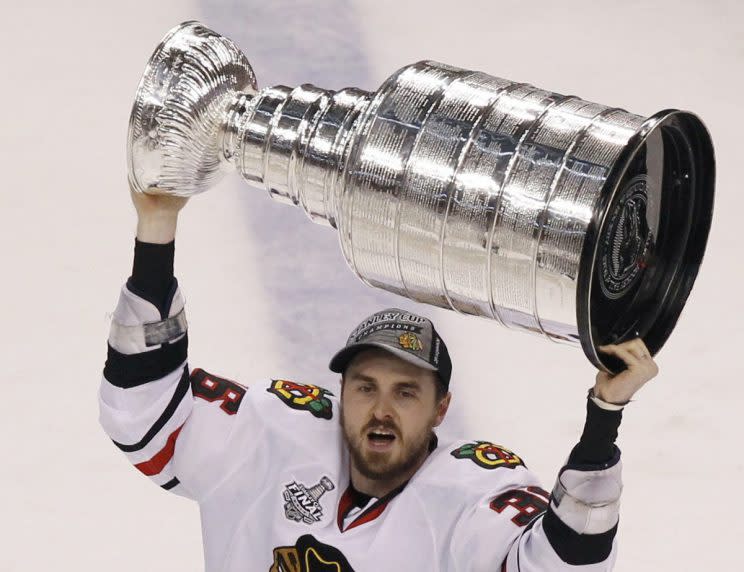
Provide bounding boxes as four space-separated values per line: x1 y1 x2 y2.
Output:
103 334 189 389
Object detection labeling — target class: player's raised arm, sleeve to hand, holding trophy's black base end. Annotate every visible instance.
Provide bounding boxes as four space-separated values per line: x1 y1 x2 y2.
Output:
453 340 658 572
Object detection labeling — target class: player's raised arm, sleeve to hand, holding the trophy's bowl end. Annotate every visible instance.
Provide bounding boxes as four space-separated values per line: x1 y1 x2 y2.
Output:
99 193 258 500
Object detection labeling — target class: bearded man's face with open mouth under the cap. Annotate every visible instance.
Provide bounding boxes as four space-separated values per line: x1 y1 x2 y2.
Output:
341 349 450 484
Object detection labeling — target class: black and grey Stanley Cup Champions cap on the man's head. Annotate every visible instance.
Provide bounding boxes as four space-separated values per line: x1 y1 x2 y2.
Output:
328 308 452 390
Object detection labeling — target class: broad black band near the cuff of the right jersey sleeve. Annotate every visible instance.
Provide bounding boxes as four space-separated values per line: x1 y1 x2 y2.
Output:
543 507 619 566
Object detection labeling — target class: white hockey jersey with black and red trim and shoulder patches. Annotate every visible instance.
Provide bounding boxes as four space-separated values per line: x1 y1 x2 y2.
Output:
99 287 620 572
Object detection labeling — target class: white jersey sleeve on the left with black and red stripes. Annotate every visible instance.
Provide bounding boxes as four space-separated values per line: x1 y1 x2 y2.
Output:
99 280 262 500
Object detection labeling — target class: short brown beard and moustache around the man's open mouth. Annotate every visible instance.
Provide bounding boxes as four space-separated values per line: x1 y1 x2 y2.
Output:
340 408 432 481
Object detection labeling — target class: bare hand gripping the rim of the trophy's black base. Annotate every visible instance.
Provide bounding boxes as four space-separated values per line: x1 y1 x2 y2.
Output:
594 338 659 404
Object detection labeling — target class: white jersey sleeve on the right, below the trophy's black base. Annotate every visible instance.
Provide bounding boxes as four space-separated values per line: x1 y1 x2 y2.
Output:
451 444 622 572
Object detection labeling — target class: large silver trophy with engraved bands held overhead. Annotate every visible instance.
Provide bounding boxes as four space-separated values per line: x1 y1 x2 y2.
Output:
128 22 715 371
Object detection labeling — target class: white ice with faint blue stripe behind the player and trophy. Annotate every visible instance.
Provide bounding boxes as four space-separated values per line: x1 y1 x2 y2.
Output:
0 0 744 572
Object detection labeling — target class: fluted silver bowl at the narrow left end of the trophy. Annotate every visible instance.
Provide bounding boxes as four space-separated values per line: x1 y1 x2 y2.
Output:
127 21 256 196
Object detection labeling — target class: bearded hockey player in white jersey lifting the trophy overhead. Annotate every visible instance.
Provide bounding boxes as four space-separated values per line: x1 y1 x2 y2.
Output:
99 193 658 572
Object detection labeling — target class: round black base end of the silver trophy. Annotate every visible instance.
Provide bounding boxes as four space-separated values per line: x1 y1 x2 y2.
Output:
577 111 715 372
